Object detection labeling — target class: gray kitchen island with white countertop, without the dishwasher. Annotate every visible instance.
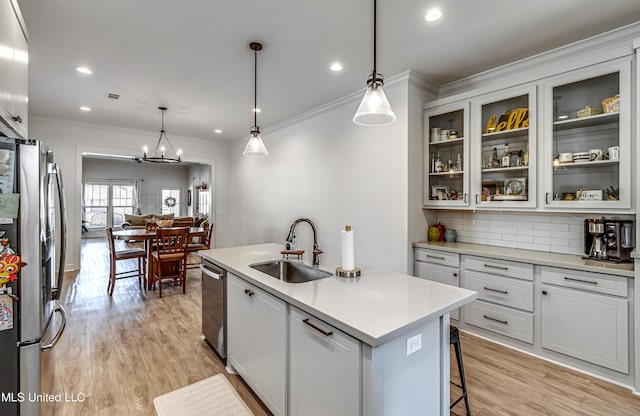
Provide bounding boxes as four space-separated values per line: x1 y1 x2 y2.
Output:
199 244 476 416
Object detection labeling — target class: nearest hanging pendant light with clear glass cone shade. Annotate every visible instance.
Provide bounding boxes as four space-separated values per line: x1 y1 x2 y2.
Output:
353 0 396 126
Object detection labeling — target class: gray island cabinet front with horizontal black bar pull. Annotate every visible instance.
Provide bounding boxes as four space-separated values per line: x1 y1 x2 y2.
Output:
289 306 361 416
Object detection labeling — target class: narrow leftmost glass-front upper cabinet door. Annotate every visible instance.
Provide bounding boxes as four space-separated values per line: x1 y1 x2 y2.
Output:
424 102 469 207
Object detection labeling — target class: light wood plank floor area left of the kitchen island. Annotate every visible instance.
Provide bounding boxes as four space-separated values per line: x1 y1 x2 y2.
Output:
46 238 267 416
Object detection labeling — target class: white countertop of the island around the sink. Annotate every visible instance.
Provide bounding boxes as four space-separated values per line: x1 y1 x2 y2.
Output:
198 243 477 347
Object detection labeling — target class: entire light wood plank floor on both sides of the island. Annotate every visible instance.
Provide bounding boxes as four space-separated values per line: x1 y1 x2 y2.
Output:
47 239 640 416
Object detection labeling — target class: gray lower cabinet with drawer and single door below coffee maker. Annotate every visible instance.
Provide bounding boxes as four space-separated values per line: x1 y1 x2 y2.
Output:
540 267 629 374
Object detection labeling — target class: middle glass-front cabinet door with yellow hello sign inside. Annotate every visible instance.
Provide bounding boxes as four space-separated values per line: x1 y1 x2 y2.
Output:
471 86 536 209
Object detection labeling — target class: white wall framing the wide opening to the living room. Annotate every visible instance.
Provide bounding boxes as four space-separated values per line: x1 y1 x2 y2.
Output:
29 117 231 270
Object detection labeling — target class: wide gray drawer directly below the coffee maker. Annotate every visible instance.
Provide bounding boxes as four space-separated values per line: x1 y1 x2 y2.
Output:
542 267 628 298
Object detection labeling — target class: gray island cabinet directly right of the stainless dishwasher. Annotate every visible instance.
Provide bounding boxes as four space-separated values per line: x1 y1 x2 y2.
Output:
227 273 287 415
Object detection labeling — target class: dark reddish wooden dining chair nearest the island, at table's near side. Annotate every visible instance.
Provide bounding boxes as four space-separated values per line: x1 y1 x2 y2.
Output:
151 227 189 297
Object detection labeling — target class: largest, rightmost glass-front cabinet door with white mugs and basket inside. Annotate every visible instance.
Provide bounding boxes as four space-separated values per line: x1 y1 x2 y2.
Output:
542 61 631 210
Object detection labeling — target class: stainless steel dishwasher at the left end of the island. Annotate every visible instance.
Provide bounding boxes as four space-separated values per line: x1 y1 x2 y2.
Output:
200 259 227 362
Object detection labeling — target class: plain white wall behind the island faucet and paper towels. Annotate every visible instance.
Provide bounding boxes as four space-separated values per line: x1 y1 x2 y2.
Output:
231 73 428 272
